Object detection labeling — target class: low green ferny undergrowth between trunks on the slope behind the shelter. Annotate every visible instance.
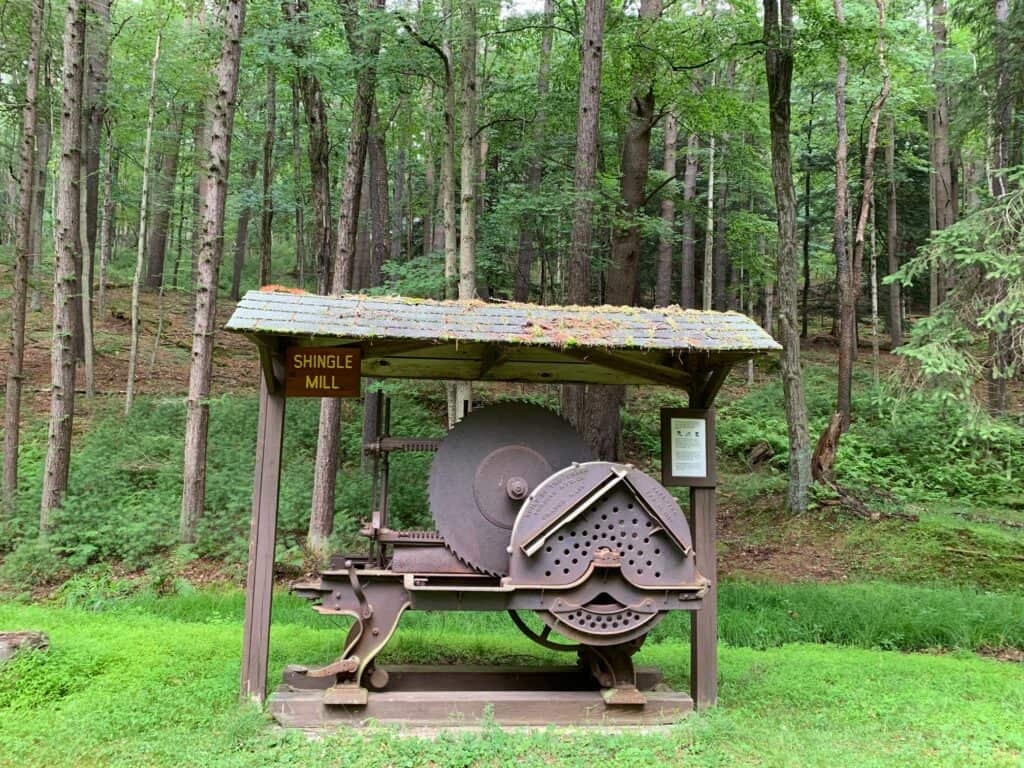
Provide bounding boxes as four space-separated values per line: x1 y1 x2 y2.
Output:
0 361 1024 589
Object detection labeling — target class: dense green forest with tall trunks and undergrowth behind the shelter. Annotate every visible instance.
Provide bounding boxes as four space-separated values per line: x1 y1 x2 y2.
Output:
0 0 1024 765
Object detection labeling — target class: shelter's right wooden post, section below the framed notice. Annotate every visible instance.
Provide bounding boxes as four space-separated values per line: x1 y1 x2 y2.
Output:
690 487 718 710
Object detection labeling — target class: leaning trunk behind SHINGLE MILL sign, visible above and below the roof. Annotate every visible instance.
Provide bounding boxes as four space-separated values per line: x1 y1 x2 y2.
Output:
306 0 384 558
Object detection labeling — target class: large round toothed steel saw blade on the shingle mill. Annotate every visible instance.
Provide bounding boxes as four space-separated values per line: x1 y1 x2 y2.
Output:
428 402 594 575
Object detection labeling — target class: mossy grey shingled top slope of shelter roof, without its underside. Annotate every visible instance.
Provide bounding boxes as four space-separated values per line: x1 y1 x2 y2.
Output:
226 291 780 354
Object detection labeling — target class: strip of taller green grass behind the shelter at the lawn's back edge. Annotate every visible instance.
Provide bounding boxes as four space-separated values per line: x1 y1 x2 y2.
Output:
29 577 1024 651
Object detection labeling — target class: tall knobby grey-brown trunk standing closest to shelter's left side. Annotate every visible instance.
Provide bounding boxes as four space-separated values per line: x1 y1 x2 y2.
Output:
180 0 246 543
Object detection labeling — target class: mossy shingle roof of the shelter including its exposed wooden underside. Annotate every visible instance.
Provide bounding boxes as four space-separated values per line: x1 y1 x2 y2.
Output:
226 289 780 389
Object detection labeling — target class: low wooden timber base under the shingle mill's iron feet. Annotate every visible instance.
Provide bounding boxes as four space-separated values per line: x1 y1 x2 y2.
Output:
268 666 693 729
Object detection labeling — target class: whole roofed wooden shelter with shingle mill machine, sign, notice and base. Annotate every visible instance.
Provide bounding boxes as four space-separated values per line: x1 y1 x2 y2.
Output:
227 289 778 727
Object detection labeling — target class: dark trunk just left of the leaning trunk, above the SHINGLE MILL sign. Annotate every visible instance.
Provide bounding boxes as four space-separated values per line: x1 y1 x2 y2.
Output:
282 0 334 293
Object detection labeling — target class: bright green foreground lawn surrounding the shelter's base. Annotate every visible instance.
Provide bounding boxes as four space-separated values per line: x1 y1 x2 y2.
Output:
0 593 1024 768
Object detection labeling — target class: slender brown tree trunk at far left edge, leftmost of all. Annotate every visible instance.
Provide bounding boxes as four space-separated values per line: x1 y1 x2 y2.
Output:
0 0 43 519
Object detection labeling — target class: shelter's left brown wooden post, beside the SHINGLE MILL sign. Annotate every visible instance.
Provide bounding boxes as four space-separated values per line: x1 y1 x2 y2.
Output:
240 347 285 703
